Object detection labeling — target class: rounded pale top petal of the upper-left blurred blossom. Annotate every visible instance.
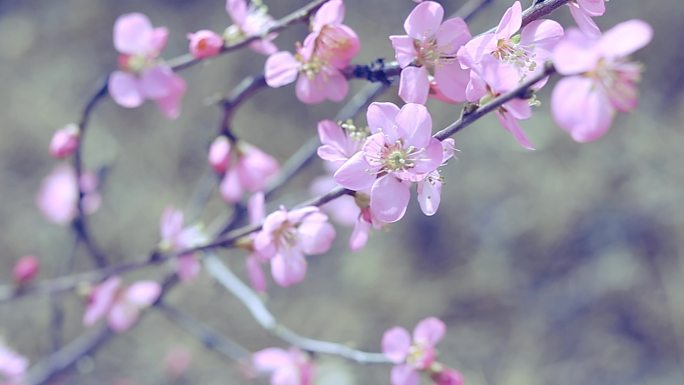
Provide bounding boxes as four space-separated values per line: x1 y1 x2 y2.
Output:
114 13 154 55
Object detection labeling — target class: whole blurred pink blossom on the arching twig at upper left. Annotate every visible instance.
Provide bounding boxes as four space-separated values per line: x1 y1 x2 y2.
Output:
108 13 186 119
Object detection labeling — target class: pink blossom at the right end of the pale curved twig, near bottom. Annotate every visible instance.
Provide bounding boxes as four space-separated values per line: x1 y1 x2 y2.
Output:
382 317 446 385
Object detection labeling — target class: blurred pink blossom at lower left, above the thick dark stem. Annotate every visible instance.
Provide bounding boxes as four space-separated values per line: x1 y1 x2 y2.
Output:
83 276 161 333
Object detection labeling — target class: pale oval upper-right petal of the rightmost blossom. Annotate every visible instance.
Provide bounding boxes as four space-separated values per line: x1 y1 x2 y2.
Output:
599 19 653 58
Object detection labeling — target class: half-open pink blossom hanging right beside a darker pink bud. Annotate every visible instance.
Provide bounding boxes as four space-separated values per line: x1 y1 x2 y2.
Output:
220 141 280 203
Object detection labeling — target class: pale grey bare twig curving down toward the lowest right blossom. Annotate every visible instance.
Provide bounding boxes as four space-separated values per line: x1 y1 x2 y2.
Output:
204 254 390 364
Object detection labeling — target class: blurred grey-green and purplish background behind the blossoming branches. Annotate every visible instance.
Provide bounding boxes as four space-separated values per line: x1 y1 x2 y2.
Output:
0 0 684 385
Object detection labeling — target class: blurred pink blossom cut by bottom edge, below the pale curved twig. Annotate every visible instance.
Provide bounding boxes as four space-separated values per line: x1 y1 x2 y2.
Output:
252 347 314 385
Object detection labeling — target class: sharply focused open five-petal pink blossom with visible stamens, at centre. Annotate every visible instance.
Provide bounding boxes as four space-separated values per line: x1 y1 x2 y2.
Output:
334 103 443 223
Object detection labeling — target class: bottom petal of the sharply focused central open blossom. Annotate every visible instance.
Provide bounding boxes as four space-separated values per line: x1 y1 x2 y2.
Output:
370 174 411 223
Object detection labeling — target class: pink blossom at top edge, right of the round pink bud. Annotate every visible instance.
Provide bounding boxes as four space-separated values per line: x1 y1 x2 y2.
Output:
224 0 278 55
